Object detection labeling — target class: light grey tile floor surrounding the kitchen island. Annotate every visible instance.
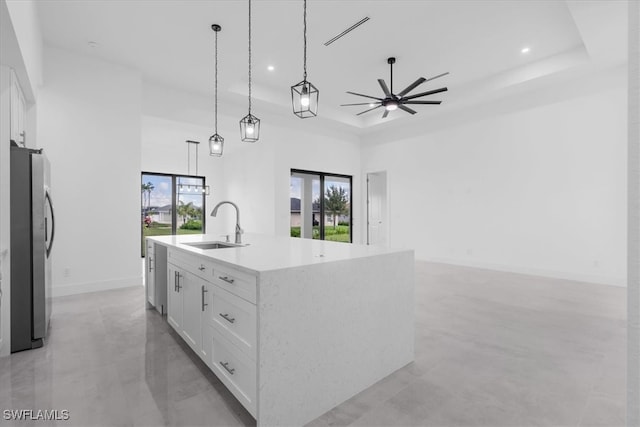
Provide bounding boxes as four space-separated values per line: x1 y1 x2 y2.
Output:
0 262 626 427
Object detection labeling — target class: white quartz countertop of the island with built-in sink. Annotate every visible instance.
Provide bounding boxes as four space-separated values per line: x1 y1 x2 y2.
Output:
148 233 408 273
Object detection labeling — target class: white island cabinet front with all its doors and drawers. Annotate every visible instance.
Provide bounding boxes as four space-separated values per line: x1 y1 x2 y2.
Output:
162 245 257 417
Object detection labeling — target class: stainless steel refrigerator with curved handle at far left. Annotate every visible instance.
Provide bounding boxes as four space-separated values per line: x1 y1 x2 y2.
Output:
10 146 55 353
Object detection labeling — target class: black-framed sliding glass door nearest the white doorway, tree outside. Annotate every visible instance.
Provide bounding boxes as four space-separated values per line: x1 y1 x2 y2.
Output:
290 169 352 243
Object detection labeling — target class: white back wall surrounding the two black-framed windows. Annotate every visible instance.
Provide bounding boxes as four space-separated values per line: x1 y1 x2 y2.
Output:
142 83 362 242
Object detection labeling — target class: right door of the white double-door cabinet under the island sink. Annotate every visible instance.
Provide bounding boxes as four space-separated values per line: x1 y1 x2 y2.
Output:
180 272 206 353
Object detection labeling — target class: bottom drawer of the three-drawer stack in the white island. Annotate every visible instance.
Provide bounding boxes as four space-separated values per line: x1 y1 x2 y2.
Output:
207 325 257 417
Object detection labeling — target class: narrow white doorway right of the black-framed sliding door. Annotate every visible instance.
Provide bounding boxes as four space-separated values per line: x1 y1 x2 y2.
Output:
367 171 389 246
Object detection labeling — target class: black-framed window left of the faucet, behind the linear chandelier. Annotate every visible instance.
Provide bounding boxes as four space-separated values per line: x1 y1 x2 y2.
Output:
141 172 206 257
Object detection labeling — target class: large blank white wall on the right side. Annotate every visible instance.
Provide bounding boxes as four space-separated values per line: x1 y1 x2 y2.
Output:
362 88 626 285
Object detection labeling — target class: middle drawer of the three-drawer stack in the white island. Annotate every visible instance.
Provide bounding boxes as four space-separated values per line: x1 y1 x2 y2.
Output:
209 286 257 360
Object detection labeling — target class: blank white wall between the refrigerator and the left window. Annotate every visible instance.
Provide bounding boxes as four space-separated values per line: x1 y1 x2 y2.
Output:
37 47 141 296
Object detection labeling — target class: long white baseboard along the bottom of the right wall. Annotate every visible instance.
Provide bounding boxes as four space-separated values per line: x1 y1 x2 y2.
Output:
416 256 627 288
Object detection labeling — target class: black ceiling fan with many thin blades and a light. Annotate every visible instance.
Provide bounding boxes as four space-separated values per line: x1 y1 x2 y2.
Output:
340 57 449 119
